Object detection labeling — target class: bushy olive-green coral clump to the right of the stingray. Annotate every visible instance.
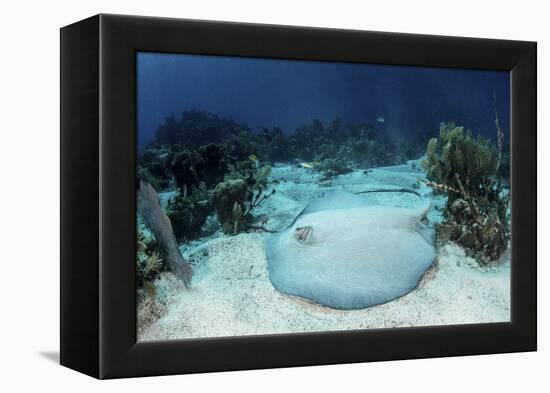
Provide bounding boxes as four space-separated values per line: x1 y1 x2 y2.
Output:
422 117 509 265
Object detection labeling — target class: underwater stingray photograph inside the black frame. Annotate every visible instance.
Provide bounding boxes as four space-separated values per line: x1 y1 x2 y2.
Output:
135 52 511 341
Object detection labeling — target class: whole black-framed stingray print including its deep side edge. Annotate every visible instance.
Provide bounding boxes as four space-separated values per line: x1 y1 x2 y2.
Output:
61 15 536 378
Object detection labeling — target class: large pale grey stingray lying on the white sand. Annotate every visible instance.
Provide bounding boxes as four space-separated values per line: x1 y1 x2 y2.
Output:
266 191 435 310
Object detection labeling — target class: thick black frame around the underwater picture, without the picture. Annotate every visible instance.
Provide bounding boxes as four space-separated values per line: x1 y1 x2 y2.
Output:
61 15 537 379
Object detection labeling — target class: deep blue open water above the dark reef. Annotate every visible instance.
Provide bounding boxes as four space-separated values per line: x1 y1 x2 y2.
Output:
137 53 510 146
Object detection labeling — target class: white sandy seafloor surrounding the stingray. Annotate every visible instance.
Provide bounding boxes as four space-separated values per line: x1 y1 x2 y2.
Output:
138 161 510 340
